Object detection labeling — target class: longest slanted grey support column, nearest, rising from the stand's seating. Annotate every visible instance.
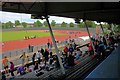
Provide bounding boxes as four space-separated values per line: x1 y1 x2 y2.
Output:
46 17 65 74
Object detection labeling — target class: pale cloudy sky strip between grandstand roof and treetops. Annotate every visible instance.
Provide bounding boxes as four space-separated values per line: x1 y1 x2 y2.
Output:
0 11 75 23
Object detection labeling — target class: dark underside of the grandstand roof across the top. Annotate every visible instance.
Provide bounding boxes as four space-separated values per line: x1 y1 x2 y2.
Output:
2 2 120 24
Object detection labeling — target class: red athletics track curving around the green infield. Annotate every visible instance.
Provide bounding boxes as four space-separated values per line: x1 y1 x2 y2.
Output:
0 30 88 52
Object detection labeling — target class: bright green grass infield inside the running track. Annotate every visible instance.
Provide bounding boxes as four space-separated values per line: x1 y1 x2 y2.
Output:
0 31 65 42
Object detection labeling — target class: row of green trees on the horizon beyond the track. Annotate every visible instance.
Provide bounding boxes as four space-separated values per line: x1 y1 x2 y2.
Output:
0 20 120 32
